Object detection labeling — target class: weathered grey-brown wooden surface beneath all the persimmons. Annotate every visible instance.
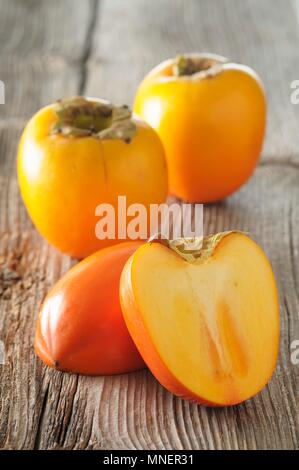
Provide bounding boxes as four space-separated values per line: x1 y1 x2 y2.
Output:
0 0 299 449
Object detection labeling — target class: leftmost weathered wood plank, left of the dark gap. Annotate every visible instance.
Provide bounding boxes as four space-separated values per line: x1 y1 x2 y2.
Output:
0 0 97 449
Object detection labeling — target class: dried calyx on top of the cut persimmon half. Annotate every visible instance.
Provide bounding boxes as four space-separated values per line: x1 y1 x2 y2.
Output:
149 230 245 264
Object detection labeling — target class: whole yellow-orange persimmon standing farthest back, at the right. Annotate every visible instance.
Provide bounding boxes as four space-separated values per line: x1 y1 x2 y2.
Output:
134 54 266 203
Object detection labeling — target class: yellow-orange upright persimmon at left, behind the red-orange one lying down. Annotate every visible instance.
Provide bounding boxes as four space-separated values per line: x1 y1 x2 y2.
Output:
18 97 168 258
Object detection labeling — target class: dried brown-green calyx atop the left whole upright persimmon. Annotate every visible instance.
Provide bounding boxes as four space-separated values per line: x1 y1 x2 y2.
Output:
52 96 136 143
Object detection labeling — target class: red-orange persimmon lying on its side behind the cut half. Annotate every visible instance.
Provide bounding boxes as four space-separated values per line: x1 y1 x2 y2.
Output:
35 241 145 375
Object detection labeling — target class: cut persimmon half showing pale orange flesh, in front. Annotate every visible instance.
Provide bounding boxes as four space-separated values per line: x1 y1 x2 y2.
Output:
120 232 279 406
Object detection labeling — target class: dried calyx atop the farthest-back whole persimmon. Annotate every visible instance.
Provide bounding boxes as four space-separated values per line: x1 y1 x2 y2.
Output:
173 55 224 78
